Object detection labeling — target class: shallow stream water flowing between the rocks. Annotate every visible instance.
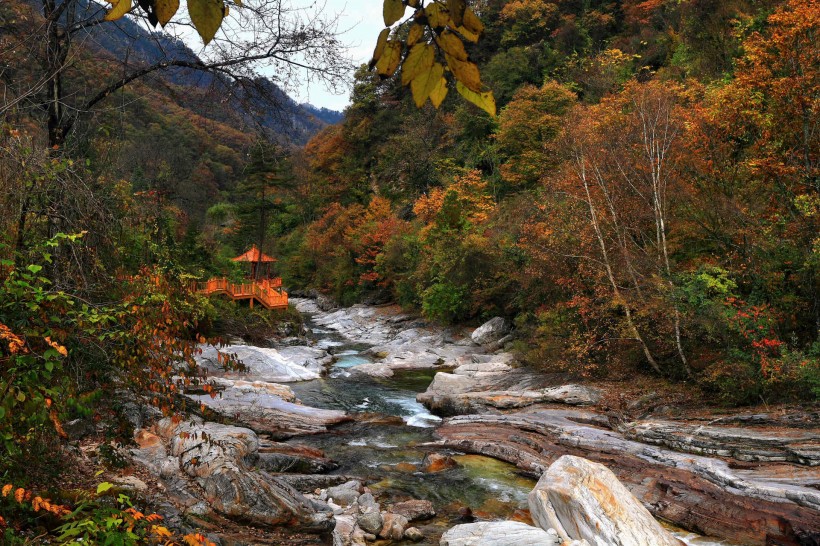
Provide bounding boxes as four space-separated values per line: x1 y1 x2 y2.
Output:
291 316 725 546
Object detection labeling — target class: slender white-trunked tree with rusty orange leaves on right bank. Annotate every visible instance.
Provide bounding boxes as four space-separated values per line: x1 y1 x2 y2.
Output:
560 81 692 375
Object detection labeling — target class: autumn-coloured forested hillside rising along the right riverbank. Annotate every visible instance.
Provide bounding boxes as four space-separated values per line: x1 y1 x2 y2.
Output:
229 0 820 402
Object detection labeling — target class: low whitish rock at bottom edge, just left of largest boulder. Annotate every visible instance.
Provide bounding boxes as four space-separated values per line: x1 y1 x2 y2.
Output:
439 521 560 546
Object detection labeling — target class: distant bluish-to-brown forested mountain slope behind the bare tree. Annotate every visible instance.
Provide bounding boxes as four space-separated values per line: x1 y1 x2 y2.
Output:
0 0 339 221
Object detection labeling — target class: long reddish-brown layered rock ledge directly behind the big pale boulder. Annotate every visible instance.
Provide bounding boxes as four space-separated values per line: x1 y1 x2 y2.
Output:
435 408 820 545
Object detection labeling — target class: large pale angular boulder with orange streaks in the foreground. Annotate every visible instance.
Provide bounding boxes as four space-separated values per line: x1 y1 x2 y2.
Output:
528 455 682 546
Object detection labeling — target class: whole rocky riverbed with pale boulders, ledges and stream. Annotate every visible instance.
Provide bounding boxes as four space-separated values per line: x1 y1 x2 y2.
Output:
123 299 820 546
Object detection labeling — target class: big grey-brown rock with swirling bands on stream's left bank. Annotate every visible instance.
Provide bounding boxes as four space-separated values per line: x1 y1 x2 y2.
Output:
158 419 334 532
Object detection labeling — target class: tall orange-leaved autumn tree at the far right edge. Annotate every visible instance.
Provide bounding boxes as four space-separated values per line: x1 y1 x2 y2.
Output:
688 2 820 343
